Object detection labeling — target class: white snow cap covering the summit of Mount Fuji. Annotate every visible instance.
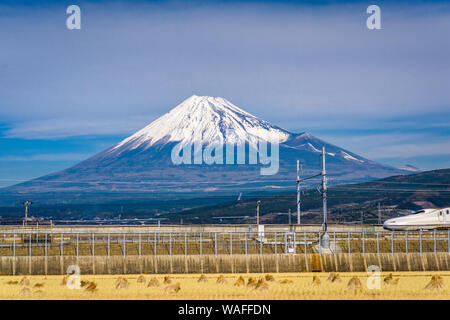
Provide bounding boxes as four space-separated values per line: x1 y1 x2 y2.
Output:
110 95 290 153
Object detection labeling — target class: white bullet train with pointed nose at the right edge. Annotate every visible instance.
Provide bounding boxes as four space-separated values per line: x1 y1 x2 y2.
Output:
383 207 450 231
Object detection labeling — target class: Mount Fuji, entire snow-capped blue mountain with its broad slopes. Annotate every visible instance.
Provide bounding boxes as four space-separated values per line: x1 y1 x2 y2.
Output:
3 95 410 201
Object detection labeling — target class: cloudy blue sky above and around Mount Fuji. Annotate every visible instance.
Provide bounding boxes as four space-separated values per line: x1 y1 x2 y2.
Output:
0 1 450 186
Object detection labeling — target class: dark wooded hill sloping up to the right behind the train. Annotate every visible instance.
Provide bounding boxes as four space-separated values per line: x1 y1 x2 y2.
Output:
170 169 450 223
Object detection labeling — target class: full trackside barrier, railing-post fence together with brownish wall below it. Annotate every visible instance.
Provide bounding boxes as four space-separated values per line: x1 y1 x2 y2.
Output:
0 225 450 275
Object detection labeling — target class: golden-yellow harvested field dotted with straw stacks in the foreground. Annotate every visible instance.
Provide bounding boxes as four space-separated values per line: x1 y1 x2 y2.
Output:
0 272 450 300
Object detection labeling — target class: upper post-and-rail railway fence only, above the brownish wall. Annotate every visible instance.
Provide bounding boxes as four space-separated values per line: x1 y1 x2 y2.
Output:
0 226 450 257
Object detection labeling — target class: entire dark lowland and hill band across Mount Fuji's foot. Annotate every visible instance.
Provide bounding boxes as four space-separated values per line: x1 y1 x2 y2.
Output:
0 169 450 223
